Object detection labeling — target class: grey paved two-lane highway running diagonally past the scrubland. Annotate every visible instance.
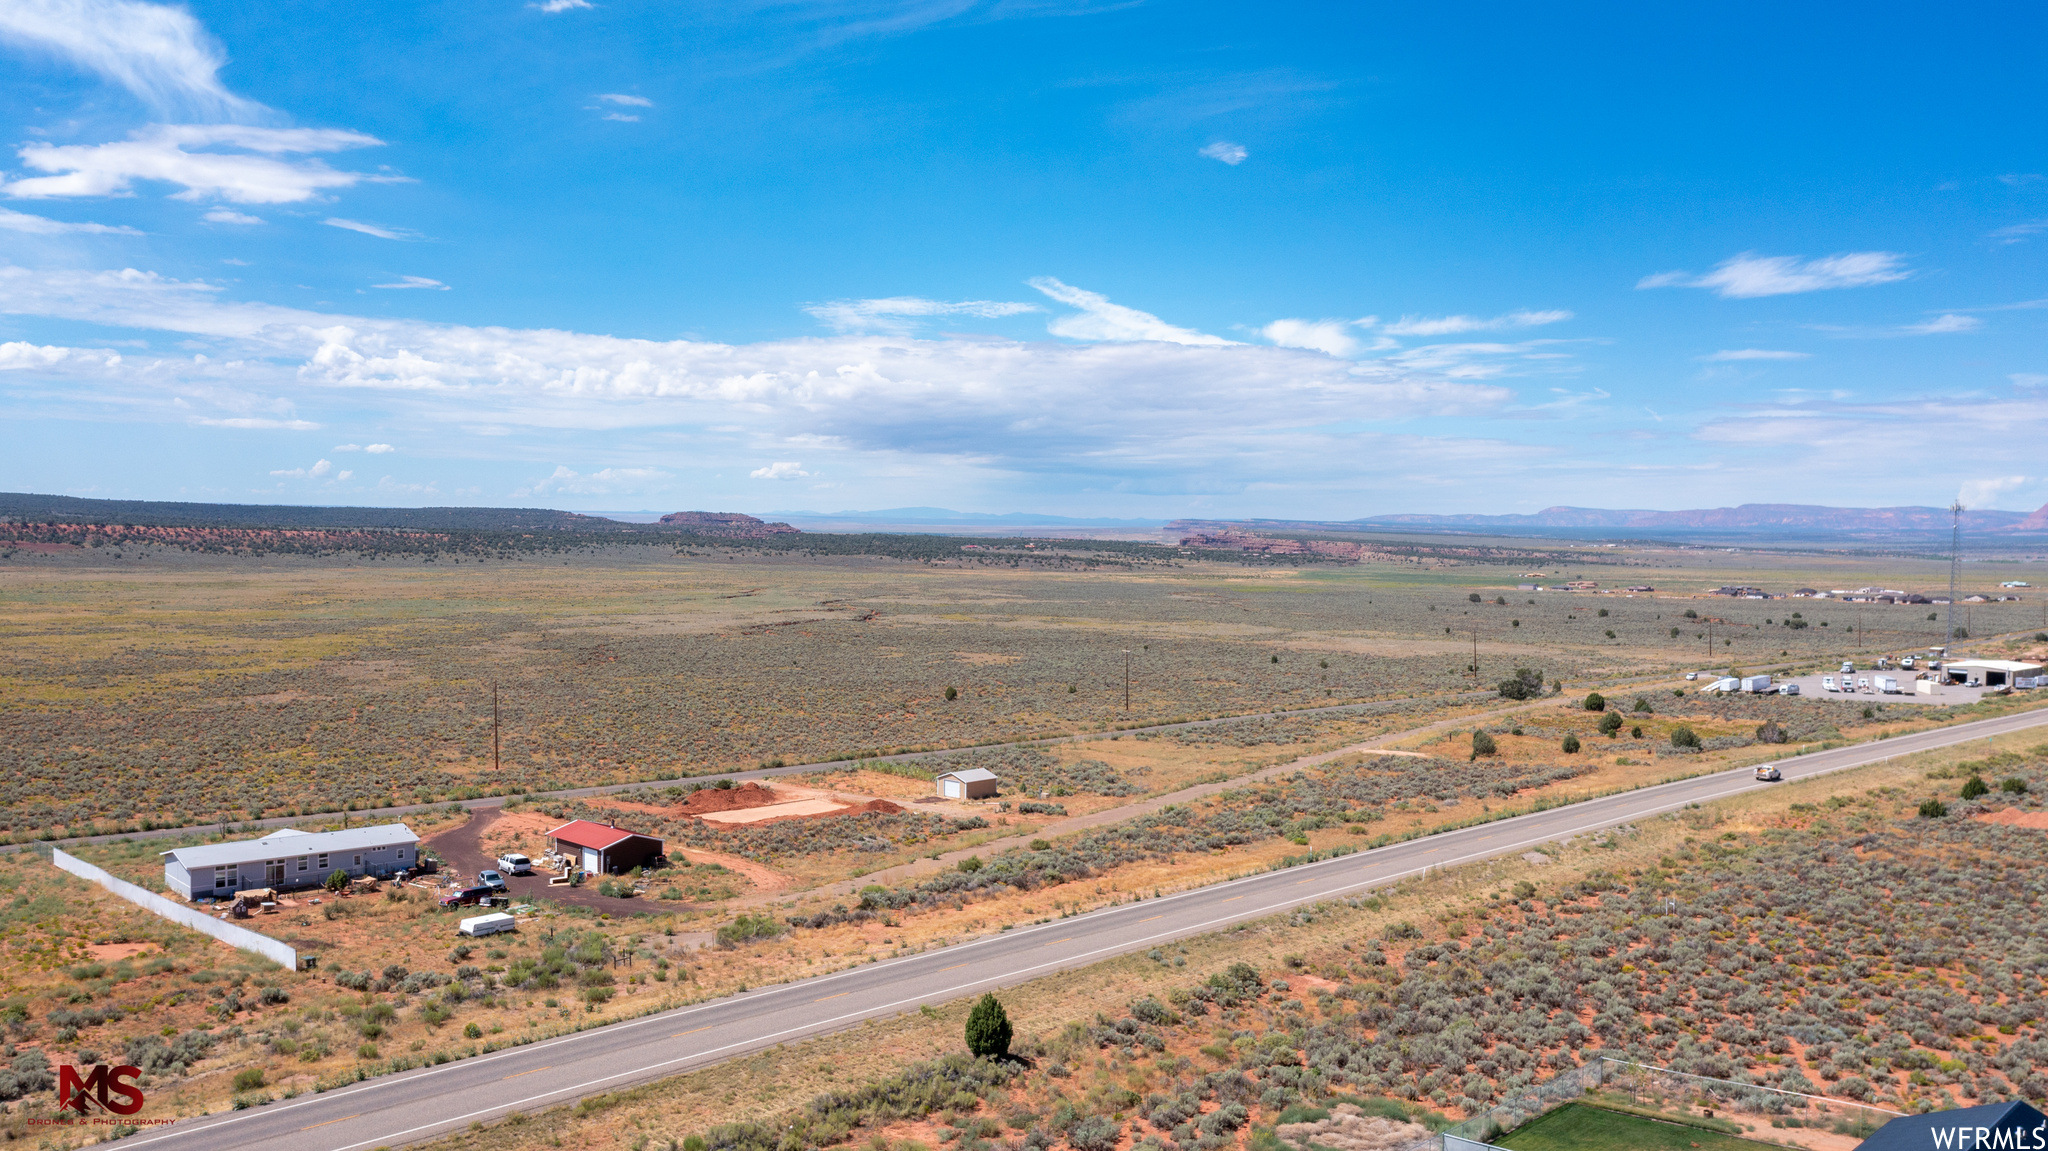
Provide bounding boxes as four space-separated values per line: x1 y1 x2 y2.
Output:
125 711 2048 1151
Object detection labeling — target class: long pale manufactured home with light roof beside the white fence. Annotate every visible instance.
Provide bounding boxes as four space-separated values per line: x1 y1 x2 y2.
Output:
164 823 420 899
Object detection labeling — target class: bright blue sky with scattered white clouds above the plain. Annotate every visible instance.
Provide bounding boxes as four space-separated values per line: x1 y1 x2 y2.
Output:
0 0 2048 518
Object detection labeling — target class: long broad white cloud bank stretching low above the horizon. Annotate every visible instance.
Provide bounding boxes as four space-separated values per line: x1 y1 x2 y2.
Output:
0 264 1531 487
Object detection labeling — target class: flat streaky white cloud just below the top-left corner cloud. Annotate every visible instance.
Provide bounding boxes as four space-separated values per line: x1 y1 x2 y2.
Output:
0 125 401 205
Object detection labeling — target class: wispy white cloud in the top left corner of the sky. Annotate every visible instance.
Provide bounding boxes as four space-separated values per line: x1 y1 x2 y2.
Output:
0 0 264 121
